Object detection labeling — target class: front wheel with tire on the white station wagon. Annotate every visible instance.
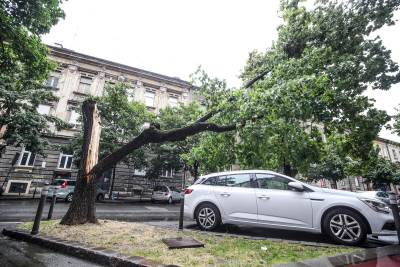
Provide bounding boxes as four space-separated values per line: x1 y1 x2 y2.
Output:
323 208 368 246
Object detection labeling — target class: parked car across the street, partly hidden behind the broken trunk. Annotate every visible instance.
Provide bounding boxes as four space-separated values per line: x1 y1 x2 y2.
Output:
47 179 106 202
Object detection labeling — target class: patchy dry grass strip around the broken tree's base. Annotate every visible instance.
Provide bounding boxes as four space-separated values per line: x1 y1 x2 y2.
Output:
19 220 354 266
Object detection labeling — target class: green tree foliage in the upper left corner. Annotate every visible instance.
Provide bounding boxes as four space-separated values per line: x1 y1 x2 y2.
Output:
0 0 66 155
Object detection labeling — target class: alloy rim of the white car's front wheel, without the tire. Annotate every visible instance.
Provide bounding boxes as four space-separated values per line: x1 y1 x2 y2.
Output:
329 214 361 242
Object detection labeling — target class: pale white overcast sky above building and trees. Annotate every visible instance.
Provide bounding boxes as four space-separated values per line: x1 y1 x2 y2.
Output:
43 0 400 141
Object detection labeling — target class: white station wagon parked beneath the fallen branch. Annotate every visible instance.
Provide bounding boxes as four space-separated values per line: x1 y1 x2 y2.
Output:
184 170 394 245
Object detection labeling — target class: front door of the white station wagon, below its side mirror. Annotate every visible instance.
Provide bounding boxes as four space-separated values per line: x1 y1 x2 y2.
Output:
256 173 313 228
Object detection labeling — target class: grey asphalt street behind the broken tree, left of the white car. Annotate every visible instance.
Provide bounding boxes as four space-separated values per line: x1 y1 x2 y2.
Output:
0 199 180 222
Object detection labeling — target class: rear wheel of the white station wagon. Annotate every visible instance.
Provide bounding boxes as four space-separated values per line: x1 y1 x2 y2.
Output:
195 203 221 231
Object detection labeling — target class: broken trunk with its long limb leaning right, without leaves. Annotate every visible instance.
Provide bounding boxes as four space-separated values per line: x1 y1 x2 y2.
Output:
61 72 260 225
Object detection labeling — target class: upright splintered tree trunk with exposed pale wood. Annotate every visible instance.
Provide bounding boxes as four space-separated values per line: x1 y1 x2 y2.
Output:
61 100 101 225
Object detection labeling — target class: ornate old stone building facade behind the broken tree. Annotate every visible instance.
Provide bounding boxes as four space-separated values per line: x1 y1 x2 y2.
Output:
0 46 196 196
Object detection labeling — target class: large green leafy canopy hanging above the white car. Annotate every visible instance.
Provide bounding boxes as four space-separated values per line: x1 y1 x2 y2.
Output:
188 0 400 176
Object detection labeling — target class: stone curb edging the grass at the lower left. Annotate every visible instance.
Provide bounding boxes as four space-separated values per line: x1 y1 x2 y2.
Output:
2 229 176 267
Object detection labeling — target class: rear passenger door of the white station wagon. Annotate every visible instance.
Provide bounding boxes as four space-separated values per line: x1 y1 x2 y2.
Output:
214 173 257 222
